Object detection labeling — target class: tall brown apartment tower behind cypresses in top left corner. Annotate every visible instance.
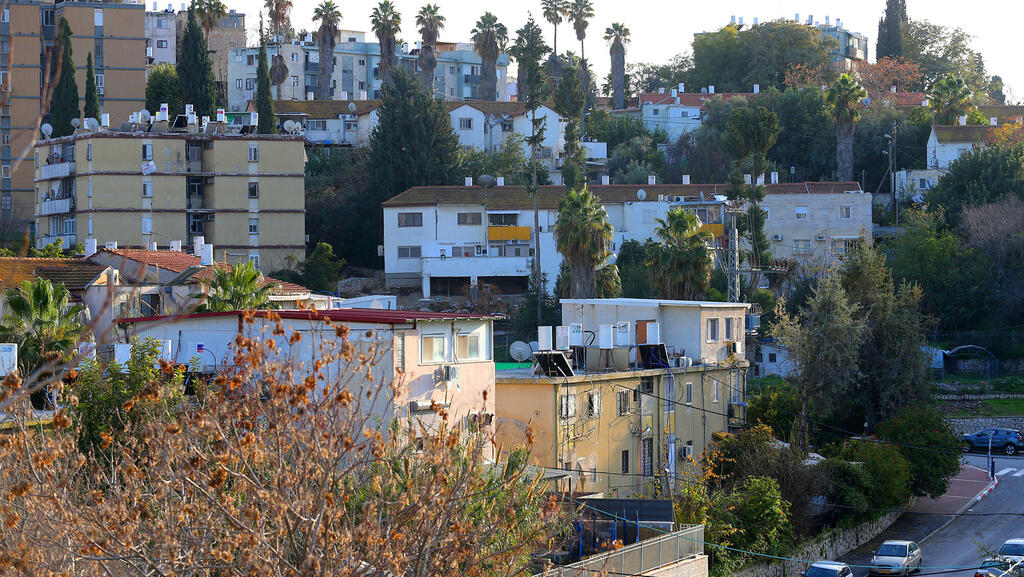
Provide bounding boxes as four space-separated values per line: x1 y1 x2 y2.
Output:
0 0 145 233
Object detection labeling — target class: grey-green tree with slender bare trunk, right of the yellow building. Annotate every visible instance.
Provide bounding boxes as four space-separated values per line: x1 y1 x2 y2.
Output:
771 275 864 449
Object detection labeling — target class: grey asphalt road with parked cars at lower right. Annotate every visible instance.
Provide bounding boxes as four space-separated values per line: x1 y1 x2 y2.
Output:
841 454 1024 577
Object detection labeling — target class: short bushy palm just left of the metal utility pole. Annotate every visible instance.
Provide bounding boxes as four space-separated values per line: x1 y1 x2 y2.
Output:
645 207 715 300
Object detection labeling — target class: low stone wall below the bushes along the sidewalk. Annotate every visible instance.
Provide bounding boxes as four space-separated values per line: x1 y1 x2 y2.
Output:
733 511 903 577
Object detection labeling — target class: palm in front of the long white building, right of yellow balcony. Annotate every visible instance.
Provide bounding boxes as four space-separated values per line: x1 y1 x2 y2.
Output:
555 187 614 298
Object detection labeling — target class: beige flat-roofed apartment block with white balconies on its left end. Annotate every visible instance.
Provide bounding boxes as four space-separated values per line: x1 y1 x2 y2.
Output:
35 117 305 270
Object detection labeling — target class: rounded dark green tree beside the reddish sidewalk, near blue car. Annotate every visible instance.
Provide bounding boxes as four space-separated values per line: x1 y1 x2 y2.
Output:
879 405 961 498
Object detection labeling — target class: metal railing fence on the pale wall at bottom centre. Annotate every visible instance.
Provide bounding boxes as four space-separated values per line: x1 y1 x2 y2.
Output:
534 525 703 577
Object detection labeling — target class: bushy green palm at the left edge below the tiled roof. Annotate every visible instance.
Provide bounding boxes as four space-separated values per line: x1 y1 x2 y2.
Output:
0 279 88 408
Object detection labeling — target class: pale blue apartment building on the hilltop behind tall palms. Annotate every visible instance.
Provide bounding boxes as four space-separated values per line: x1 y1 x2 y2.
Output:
227 31 509 111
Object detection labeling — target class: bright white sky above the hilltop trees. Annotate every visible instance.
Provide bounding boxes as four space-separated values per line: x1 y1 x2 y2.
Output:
232 0 1024 101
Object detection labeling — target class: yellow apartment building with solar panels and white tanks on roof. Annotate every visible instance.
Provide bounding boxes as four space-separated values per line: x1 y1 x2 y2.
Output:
495 298 750 498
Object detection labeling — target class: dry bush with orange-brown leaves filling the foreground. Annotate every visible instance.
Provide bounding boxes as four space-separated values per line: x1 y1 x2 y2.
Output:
0 313 559 576
